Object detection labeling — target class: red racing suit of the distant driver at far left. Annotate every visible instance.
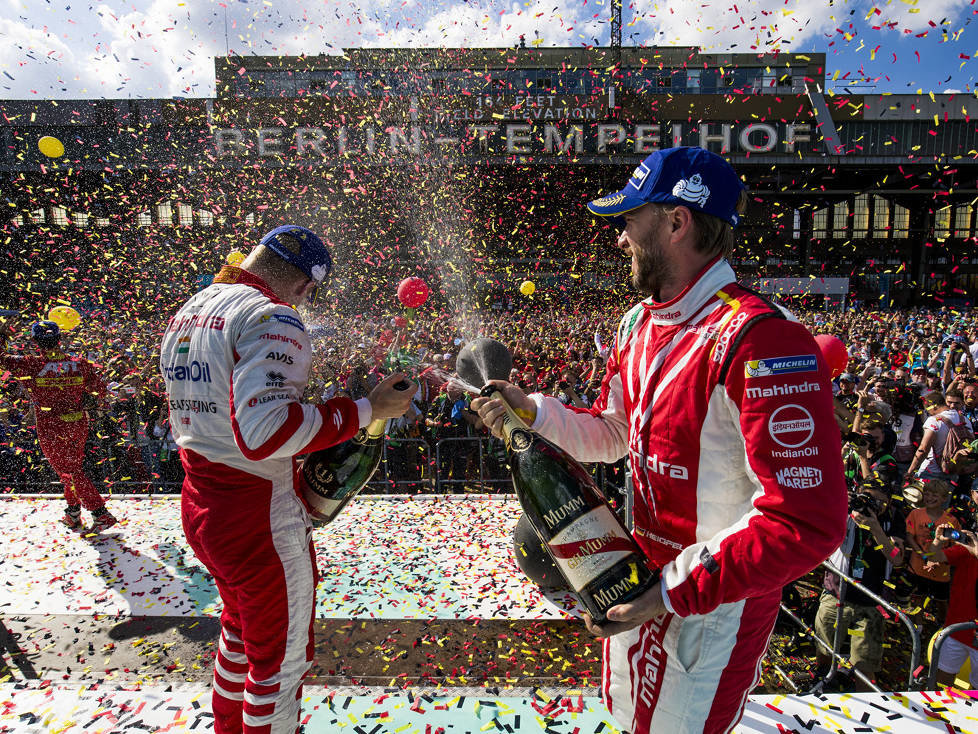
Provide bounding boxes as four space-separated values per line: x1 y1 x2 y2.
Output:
0 350 105 511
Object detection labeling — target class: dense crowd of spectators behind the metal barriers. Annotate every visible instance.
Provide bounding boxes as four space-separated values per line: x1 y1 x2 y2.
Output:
0 296 978 687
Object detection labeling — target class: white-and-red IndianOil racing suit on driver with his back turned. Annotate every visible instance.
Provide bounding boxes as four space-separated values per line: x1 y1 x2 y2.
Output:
160 267 370 733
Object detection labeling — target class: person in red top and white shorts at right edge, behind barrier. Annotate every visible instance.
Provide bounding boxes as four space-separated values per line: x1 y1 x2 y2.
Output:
928 524 978 688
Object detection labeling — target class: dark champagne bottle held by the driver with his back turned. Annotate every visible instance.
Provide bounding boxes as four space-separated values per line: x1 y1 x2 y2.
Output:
299 418 390 523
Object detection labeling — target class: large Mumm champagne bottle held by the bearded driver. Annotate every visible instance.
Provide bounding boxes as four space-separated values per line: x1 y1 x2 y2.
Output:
482 385 660 624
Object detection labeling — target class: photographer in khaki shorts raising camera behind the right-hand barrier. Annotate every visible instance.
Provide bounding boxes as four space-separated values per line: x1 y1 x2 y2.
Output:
815 477 906 690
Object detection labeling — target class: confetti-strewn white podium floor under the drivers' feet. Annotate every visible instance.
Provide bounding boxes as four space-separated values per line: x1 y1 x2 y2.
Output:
0 495 978 734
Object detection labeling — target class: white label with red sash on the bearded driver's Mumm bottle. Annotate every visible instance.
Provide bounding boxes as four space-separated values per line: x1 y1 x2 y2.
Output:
547 505 635 591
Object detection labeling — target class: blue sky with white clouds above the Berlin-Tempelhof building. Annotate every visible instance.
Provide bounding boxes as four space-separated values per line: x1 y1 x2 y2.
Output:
0 0 978 99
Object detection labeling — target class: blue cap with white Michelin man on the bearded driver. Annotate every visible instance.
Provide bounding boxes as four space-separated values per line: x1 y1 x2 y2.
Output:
587 147 746 227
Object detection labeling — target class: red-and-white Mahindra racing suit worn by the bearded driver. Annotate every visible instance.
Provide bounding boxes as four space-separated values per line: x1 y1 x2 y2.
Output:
533 259 846 734
